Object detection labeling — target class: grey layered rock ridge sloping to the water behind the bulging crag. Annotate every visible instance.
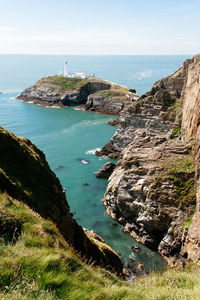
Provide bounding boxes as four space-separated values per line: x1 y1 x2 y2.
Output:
97 63 188 158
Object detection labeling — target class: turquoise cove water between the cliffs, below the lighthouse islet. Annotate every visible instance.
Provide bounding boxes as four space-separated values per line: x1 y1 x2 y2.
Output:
0 93 163 270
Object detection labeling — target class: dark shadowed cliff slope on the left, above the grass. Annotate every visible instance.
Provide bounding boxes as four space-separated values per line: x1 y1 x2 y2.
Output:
0 127 122 273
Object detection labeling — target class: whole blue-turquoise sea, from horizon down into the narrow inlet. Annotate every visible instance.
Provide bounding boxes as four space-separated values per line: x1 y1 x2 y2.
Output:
0 55 192 271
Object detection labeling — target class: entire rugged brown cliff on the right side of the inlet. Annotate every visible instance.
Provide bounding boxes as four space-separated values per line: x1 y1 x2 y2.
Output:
97 56 200 265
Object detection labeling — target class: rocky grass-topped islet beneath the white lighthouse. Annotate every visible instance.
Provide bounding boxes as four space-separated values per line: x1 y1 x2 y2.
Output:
17 75 138 115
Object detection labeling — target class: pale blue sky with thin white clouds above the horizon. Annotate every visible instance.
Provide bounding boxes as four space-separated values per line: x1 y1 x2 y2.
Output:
0 0 200 55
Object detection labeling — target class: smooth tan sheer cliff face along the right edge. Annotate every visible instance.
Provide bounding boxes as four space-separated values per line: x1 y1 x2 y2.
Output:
182 55 200 261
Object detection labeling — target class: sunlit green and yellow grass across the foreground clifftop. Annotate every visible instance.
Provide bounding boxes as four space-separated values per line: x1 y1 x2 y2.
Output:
0 193 200 300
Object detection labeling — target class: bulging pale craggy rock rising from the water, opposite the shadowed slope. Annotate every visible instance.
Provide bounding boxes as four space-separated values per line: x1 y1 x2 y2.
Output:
103 135 194 252
